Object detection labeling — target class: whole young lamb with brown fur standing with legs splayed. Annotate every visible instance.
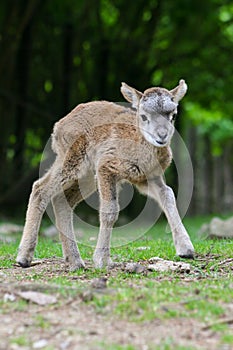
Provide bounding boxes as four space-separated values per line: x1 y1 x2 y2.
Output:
17 81 193 270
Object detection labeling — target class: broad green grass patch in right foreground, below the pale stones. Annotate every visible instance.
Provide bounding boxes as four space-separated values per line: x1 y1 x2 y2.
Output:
88 277 233 323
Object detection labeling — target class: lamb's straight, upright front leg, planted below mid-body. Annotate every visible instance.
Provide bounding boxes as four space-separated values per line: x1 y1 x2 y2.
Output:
93 167 119 268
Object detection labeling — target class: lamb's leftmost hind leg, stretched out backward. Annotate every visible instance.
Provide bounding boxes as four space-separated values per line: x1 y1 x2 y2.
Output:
16 168 59 267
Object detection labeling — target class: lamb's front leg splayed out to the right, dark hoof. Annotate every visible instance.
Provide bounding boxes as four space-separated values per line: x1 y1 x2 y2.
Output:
144 177 194 259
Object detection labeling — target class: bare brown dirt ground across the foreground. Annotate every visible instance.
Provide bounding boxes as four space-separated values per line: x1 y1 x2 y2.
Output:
0 258 233 350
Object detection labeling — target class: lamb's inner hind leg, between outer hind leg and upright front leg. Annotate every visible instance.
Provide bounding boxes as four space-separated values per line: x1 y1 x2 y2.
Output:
52 182 85 271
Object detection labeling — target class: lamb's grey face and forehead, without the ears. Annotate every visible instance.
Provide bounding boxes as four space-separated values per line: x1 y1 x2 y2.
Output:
138 88 178 147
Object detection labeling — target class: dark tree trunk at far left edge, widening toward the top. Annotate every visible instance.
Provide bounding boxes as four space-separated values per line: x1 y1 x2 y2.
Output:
0 0 40 192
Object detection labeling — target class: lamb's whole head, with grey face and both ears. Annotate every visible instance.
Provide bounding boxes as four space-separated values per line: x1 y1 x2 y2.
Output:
121 80 187 147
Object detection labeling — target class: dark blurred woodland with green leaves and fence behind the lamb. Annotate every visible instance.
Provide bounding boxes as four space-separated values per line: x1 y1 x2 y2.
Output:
0 0 233 216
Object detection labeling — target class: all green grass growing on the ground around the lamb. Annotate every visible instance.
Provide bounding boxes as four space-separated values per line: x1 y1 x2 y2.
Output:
0 218 233 350
